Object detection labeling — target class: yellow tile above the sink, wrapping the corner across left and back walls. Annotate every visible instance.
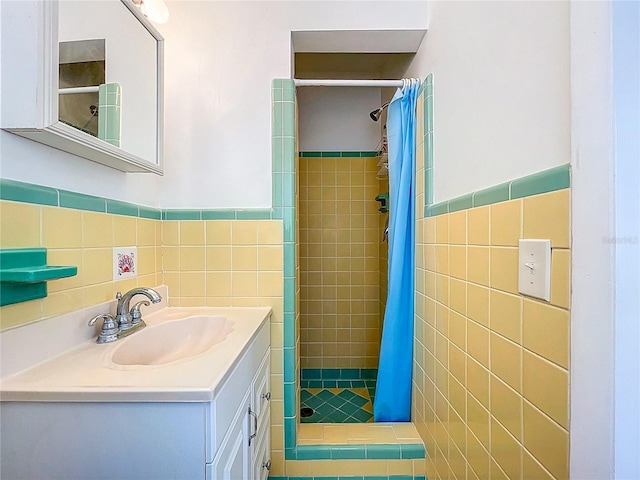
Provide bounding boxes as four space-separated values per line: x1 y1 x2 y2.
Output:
0 201 283 343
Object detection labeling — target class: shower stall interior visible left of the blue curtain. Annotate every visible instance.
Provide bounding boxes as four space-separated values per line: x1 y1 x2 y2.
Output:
297 87 396 423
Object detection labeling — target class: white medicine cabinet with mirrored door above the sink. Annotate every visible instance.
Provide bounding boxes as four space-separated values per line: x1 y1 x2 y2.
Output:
2 0 163 173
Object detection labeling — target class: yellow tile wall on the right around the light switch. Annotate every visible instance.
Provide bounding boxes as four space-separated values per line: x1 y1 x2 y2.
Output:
413 189 571 479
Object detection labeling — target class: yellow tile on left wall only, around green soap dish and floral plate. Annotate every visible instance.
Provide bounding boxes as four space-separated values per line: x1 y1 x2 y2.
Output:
0 201 162 329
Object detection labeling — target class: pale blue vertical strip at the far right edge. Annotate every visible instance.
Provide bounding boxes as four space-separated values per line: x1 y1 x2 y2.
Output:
612 2 640 479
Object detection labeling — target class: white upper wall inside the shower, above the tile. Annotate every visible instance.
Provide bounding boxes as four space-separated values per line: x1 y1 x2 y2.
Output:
296 87 383 151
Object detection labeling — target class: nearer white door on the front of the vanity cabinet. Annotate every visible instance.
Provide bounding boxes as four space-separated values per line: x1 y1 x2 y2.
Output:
207 392 251 480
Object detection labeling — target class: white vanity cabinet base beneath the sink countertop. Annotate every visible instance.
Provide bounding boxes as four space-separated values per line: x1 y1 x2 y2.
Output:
0 318 270 480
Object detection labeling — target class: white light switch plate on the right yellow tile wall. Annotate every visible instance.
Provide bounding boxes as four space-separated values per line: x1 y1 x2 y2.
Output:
518 239 551 302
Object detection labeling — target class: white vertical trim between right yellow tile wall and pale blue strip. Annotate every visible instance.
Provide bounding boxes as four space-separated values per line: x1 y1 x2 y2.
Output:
569 2 616 480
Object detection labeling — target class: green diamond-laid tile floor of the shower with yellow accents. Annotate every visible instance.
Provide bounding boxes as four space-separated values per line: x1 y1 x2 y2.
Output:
300 380 375 423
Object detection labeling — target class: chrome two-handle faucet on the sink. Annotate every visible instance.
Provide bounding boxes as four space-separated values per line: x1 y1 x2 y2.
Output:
89 287 162 343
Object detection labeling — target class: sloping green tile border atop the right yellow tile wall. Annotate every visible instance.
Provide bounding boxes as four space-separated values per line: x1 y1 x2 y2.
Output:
424 163 571 217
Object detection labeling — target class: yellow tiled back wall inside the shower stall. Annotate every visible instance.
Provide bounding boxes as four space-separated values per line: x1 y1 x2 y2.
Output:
298 157 381 368
